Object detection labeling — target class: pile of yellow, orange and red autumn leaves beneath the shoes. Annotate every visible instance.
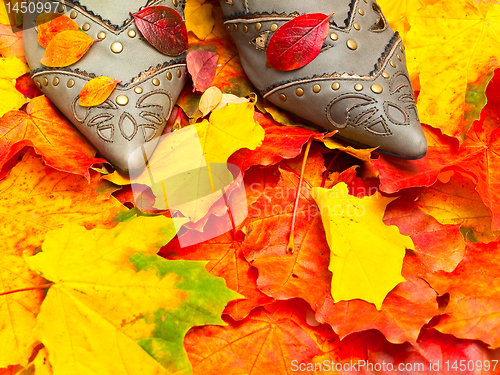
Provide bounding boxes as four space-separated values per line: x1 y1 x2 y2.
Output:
0 0 500 375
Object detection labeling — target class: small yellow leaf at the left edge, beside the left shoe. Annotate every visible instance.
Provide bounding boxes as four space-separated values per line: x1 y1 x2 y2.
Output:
0 55 29 117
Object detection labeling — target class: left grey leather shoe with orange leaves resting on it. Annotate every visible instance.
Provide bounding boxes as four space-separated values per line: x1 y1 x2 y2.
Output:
23 0 187 171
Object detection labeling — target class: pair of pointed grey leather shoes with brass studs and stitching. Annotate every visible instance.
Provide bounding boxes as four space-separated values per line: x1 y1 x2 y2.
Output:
23 0 427 171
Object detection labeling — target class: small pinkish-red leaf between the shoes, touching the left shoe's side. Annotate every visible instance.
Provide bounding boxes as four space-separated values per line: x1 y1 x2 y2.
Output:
187 51 219 92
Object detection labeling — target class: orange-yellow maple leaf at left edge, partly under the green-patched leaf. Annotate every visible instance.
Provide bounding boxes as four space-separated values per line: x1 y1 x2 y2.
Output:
0 154 125 368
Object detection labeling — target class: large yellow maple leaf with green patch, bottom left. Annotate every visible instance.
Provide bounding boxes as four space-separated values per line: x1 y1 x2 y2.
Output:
26 216 241 375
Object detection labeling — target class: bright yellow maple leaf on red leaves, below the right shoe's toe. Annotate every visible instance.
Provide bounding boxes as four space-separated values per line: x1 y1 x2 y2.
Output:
311 182 414 310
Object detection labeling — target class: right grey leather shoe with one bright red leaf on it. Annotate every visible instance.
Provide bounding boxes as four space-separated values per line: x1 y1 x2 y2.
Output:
221 0 427 159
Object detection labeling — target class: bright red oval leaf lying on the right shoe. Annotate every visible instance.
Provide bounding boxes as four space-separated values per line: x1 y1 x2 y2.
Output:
266 13 333 71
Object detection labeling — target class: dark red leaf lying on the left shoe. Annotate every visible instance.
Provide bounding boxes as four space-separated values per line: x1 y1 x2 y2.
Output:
131 5 188 56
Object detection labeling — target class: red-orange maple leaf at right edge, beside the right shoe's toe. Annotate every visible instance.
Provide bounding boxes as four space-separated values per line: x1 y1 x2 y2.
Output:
374 71 500 231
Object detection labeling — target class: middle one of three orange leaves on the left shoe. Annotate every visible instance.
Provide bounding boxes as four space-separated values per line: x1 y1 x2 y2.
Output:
41 30 94 68
